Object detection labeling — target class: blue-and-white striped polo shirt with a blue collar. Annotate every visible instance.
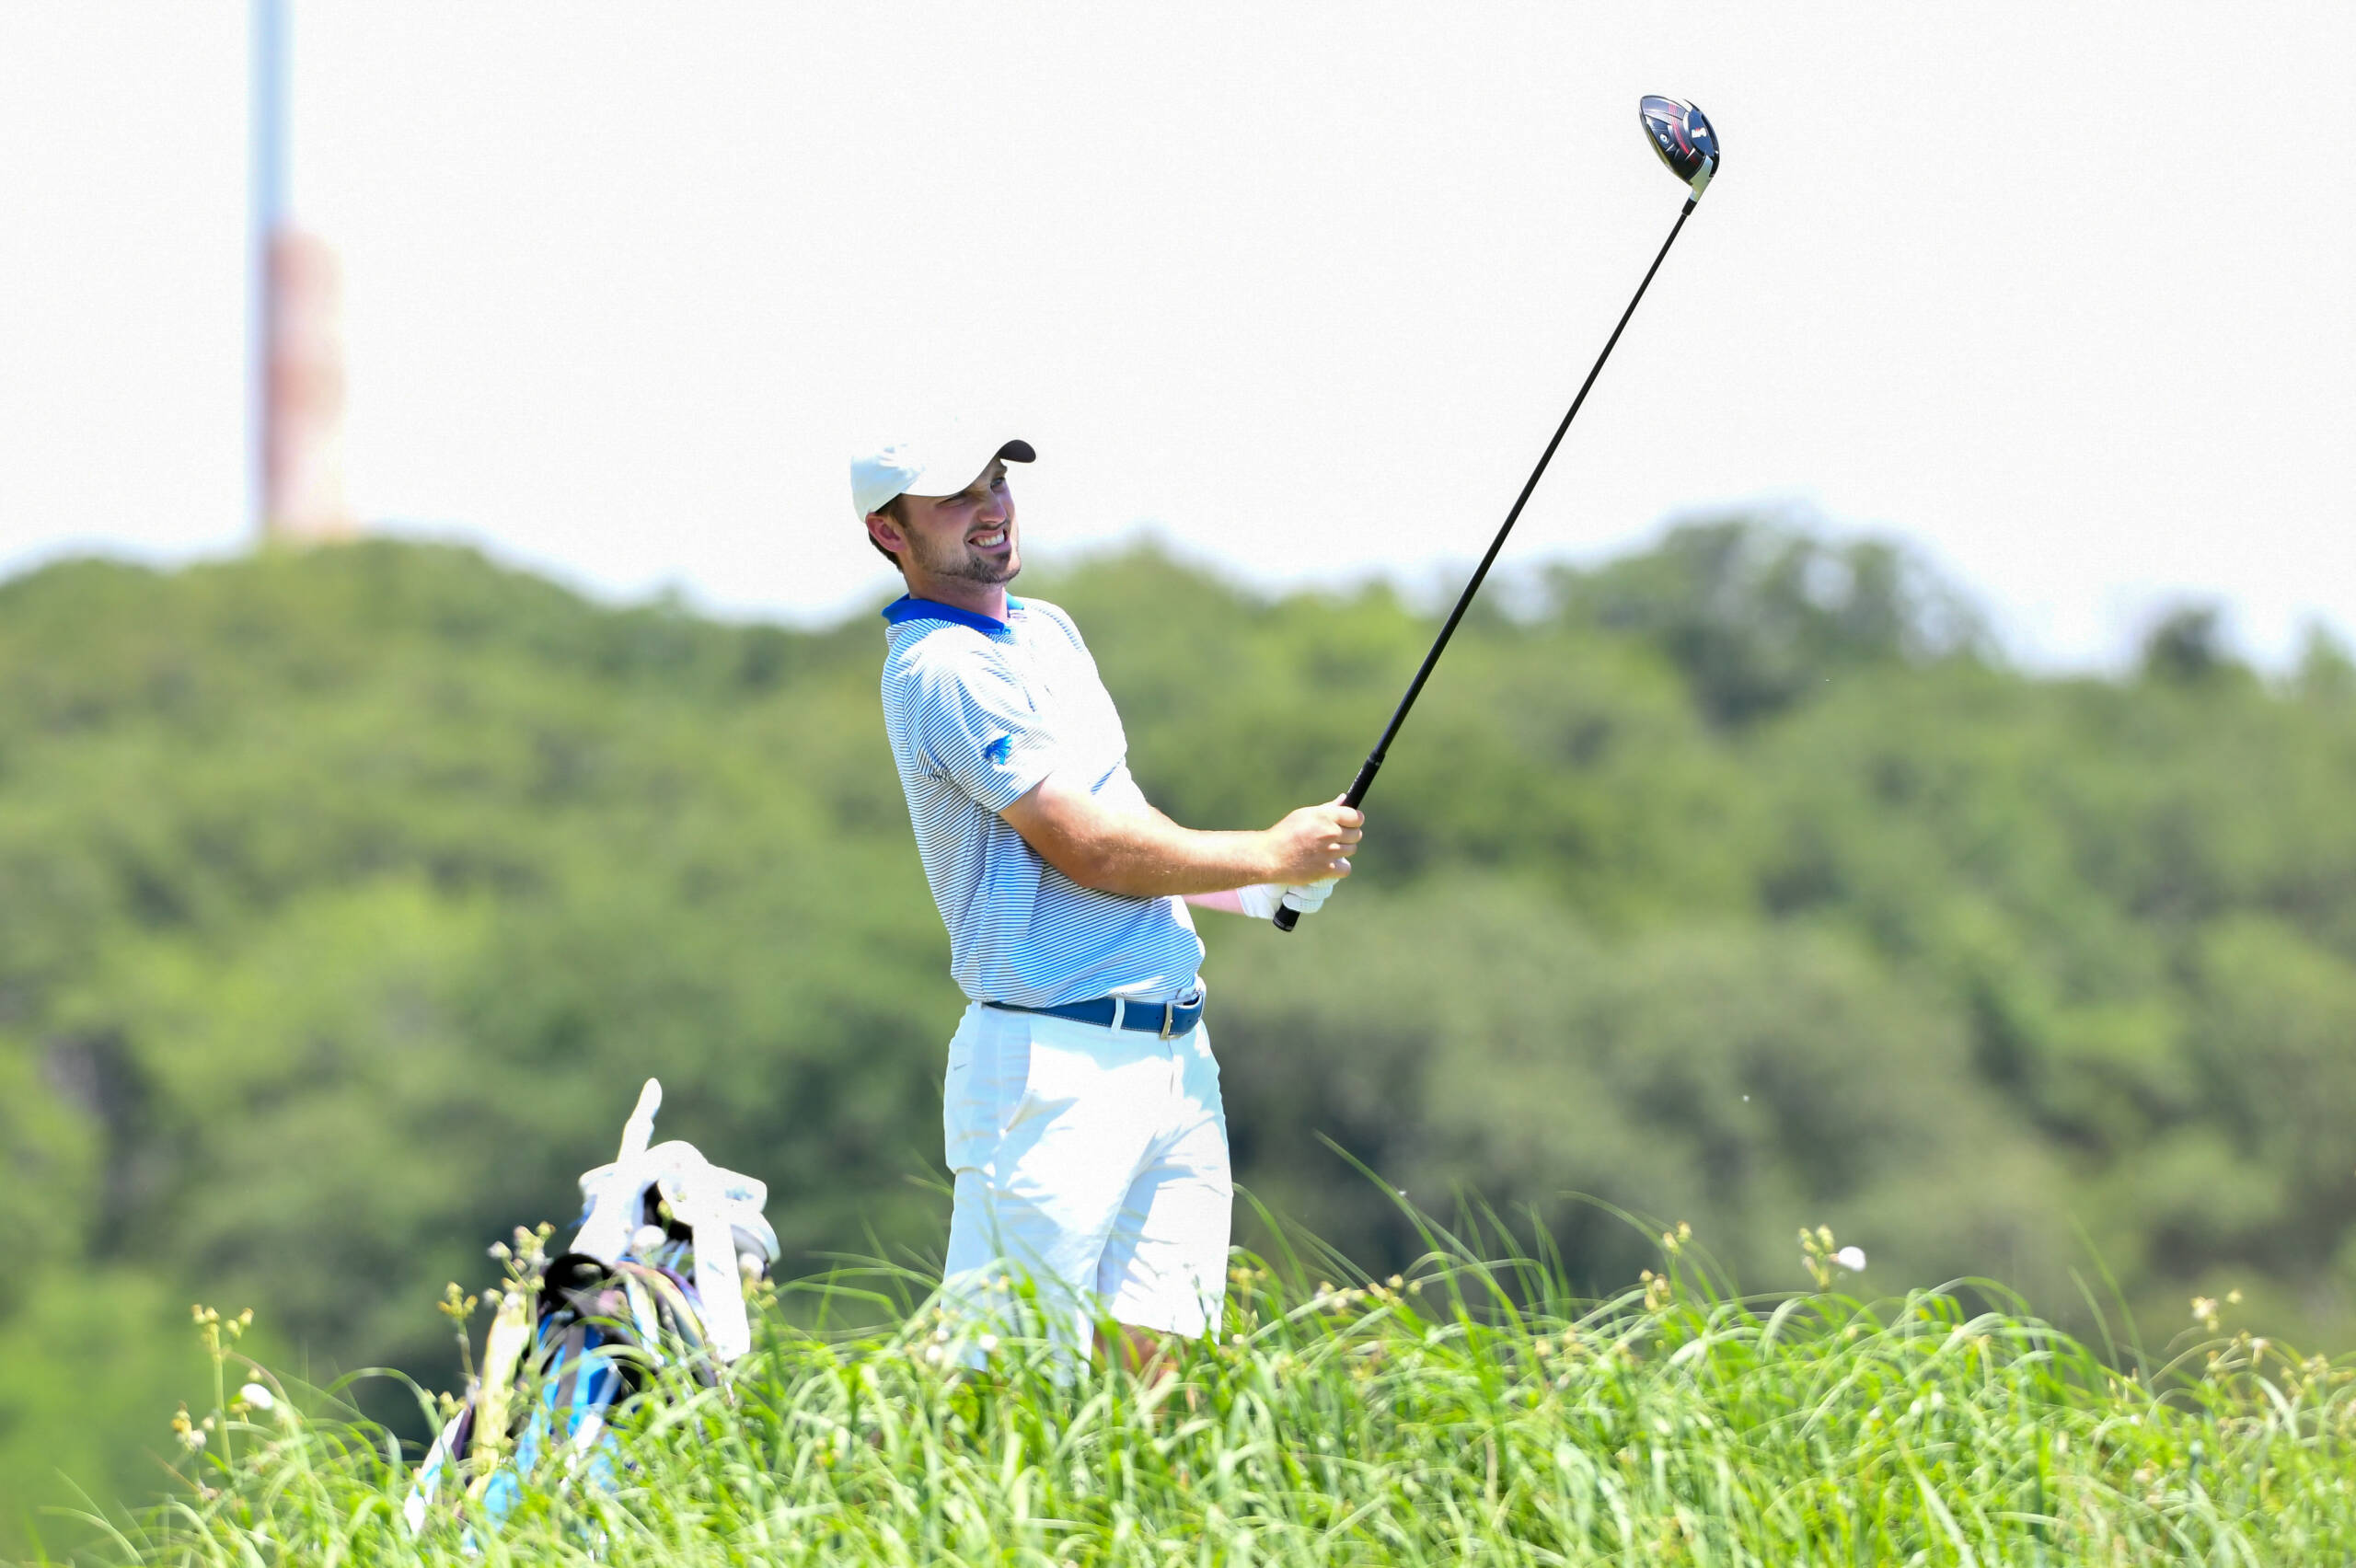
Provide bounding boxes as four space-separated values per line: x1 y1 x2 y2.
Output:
884 598 1202 1008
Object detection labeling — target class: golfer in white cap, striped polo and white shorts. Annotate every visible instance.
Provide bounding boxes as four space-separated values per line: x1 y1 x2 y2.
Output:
850 426 1364 1363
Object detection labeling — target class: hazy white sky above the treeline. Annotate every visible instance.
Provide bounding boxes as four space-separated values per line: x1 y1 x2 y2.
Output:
0 0 2356 664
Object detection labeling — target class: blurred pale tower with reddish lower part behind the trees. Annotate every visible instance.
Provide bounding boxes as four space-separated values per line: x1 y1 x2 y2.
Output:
248 0 358 544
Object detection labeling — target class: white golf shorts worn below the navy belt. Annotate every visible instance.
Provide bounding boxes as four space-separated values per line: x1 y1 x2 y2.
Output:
940 1003 1234 1346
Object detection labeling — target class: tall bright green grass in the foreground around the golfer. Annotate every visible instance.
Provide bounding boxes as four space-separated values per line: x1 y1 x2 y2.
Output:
55 1205 2356 1568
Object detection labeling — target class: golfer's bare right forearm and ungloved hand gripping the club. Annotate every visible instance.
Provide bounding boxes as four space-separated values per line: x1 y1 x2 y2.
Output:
999 775 1367 899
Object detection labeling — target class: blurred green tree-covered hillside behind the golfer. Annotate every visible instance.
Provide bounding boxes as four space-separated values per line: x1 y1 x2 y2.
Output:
0 520 2356 1542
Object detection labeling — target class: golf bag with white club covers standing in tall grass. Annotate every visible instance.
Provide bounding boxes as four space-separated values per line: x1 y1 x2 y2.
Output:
403 1078 778 1530
